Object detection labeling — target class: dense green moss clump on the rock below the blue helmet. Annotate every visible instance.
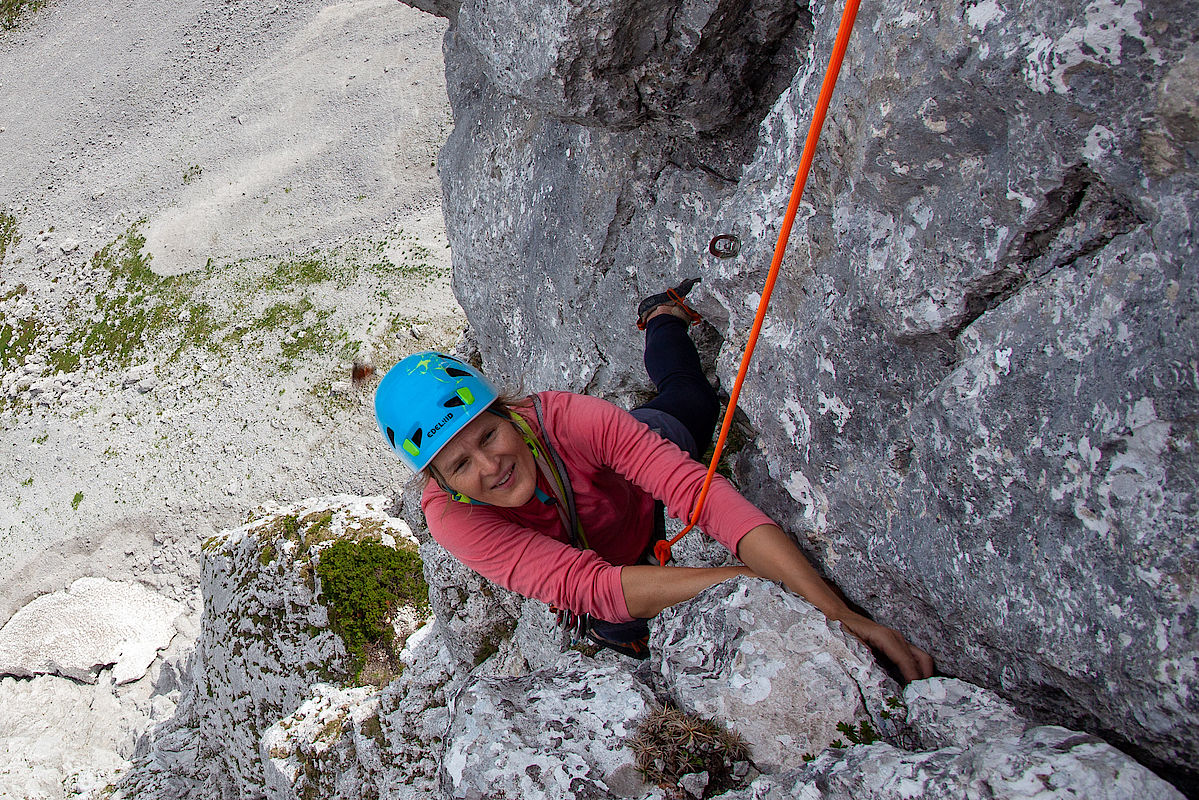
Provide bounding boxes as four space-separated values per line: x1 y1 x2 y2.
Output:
317 540 429 678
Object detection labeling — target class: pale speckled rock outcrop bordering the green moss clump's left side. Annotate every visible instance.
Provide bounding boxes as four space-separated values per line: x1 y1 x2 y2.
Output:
120 497 426 800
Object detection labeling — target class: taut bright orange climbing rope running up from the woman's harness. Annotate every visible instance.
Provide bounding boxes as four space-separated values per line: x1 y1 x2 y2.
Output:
653 0 861 564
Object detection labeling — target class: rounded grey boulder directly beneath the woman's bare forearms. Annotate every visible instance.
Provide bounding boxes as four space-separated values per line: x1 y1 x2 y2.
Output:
651 578 899 771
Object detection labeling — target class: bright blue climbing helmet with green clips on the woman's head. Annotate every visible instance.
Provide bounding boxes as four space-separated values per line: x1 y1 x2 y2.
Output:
375 350 499 473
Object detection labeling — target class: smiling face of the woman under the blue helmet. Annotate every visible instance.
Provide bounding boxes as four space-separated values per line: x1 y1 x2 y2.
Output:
429 414 537 509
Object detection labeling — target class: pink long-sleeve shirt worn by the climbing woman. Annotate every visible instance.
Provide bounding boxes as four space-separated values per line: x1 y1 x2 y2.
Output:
421 392 773 622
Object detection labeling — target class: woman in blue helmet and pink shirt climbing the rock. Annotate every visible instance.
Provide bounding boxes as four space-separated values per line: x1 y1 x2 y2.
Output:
375 279 933 680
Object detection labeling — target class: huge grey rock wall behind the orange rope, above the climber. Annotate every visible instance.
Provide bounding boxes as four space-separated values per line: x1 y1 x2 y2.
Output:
426 0 1199 786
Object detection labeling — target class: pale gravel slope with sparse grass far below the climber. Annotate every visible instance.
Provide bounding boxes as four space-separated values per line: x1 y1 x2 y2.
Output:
0 0 464 798
